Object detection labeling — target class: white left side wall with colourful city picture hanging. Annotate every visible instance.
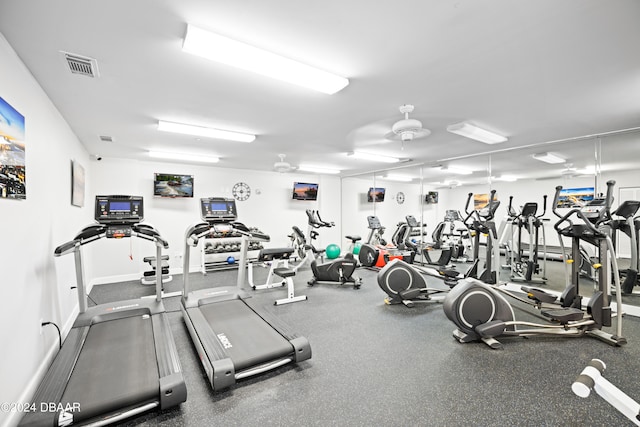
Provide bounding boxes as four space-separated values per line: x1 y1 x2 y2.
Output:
0 35 91 425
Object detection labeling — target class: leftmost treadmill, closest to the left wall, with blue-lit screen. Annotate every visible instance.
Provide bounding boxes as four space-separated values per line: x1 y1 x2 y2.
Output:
19 196 187 426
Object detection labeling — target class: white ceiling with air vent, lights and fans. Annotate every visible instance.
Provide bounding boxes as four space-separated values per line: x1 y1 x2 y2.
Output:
0 0 640 184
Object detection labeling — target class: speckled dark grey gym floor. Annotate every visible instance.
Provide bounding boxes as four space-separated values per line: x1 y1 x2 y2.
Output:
91 262 640 426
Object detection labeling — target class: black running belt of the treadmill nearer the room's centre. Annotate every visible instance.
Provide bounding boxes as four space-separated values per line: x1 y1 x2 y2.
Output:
200 299 293 372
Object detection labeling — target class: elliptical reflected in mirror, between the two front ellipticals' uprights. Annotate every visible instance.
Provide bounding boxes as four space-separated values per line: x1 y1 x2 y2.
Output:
509 194 547 283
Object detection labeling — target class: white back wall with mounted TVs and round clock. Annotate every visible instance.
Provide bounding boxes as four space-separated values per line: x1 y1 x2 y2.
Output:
86 158 340 283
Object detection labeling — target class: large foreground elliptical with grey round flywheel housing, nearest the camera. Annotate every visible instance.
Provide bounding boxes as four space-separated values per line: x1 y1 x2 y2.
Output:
443 181 627 349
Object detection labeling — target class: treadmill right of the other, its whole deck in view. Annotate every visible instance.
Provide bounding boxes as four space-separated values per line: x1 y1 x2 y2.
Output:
181 197 311 391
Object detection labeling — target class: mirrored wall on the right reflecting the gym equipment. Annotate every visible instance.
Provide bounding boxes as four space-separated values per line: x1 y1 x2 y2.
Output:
341 129 640 300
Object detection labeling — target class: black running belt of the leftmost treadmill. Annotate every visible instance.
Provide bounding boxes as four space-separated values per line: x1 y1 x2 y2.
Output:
61 316 160 424
